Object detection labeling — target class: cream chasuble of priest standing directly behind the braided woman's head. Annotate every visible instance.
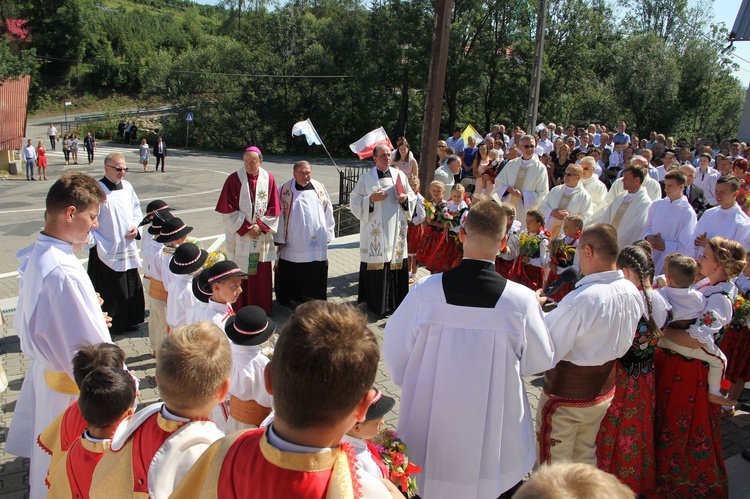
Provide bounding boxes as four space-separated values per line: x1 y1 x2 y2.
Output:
587 187 651 248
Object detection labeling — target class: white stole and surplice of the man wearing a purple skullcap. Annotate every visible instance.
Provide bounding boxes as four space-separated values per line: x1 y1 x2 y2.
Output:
222 167 279 275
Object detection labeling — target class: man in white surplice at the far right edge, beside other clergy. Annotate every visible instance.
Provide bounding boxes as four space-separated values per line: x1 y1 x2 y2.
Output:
693 175 750 259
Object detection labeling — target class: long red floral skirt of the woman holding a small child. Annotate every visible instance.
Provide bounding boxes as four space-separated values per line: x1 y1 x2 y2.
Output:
647 348 729 498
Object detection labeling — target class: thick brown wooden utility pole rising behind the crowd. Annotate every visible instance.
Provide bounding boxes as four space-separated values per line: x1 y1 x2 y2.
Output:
419 0 453 188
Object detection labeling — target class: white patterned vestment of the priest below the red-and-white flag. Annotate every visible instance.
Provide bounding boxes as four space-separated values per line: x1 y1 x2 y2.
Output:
350 168 417 270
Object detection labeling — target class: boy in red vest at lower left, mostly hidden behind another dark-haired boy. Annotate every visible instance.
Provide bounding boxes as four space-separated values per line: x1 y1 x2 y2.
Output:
36 343 131 486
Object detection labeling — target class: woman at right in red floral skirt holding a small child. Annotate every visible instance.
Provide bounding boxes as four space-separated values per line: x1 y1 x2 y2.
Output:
654 237 745 497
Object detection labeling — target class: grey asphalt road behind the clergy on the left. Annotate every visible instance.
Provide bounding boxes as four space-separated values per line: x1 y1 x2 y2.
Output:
0 117 372 278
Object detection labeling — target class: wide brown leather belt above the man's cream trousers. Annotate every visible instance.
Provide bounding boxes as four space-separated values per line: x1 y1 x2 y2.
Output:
544 360 615 399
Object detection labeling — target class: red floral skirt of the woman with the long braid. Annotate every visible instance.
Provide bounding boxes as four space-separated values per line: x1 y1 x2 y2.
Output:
596 360 655 494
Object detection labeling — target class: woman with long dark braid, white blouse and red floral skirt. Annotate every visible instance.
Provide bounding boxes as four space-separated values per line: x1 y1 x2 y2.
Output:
596 245 669 494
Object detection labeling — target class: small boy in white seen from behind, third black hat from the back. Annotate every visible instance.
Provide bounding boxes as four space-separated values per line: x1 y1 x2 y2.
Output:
167 243 208 329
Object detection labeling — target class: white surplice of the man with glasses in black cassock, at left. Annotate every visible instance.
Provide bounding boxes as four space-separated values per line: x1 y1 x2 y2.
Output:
91 180 143 272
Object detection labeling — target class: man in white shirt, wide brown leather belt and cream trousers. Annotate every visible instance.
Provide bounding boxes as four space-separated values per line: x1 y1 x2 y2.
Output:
536 224 644 465
